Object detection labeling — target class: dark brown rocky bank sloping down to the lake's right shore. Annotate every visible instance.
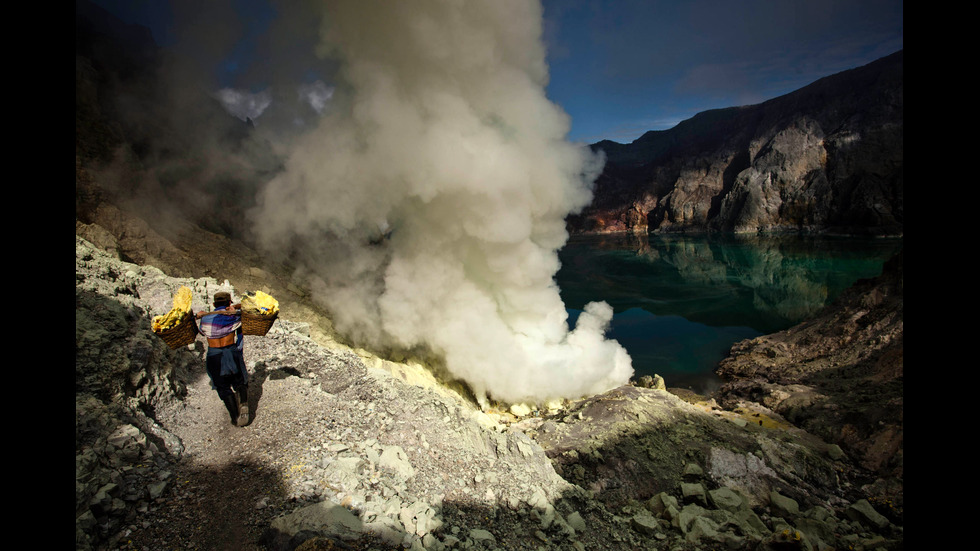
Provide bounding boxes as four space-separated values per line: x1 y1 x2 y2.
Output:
718 252 904 492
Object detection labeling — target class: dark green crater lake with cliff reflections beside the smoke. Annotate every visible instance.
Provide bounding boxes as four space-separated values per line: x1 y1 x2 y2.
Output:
556 234 902 392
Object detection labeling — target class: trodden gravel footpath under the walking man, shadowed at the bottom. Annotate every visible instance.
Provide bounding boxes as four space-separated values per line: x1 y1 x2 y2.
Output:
129 343 350 550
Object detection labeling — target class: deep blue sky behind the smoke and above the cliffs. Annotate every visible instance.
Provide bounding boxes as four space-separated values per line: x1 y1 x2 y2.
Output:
86 0 904 143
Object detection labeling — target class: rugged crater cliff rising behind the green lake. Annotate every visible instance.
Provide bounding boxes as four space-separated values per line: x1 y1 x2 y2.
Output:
569 51 904 235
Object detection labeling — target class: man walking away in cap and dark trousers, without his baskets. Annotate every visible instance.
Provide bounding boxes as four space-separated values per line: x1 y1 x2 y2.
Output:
197 291 248 427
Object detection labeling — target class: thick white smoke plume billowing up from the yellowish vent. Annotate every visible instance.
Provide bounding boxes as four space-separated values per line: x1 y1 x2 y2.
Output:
256 0 633 403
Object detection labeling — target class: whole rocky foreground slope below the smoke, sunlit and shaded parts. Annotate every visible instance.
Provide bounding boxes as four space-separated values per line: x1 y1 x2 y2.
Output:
76 237 903 549
